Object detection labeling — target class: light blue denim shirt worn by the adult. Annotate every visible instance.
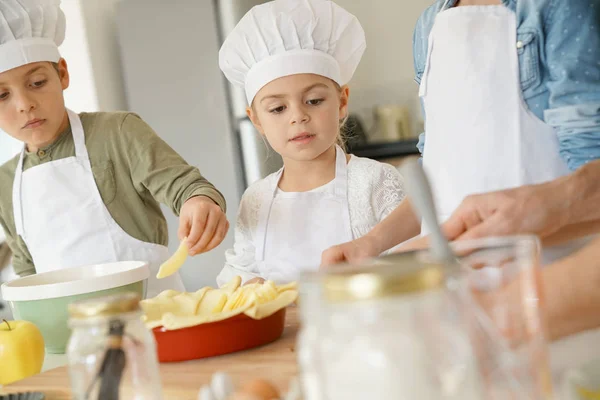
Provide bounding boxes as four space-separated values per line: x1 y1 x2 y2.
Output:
413 0 600 170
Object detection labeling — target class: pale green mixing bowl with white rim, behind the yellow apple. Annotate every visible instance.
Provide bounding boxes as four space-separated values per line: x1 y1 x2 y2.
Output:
2 261 150 354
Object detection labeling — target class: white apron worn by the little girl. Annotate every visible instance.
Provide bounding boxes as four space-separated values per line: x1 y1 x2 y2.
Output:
256 146 353 283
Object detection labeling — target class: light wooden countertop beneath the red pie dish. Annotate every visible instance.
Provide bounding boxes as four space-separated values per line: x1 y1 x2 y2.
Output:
0 307 298 400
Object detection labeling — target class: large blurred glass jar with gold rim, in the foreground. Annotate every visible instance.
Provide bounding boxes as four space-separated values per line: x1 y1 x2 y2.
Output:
298 253 480 400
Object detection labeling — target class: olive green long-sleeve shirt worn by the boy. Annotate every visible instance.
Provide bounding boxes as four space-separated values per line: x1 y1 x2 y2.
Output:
0 112 225 276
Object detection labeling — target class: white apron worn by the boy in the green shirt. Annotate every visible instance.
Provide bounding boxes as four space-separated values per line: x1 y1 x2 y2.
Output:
13 110 185 297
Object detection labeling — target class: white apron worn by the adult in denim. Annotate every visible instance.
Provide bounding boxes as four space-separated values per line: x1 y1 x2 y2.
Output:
419 5 584 262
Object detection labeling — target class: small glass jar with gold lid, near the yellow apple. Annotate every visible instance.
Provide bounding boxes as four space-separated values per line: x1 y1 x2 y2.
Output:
67 293 162 400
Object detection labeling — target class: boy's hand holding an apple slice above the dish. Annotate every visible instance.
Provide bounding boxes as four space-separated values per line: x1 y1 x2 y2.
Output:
177 196 229 256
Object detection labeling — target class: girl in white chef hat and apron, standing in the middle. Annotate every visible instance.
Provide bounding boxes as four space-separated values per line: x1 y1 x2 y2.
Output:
217 0 404 285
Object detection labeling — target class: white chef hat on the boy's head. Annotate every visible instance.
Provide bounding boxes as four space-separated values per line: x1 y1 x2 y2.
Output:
0 0 66 73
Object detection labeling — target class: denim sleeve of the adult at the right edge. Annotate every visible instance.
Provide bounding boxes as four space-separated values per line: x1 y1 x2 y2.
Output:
544 0 600 170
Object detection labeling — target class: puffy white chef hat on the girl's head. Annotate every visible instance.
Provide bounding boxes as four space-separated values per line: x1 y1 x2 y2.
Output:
219 0 366 104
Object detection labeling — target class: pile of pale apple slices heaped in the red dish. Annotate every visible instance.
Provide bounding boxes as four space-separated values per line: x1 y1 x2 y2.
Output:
140 276 298 330
